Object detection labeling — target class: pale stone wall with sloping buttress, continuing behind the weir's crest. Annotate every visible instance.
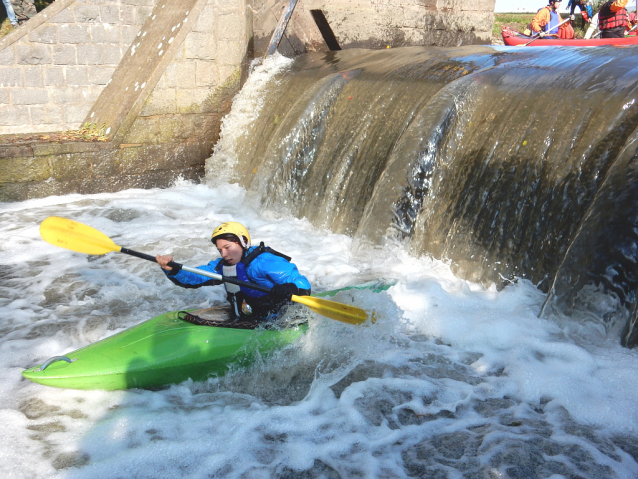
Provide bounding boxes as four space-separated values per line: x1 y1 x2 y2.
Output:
0 0 494 201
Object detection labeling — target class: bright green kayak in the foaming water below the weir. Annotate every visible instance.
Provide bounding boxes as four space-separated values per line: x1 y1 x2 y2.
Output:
22 282 392 390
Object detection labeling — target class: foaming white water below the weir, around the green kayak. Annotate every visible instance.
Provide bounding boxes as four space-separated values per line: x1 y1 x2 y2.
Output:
0 54 638 479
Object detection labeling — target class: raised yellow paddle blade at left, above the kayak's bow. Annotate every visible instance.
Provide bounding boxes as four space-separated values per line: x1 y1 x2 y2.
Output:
40 216 121 254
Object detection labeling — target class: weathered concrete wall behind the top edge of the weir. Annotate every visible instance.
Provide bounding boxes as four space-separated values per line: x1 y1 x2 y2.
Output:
253 0 495 55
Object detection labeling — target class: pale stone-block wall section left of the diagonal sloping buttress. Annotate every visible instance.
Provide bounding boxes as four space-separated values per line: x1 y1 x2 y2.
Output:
0 0 156 134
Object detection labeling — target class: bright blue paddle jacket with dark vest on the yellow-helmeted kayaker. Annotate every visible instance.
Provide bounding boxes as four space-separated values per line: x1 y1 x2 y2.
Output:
163 243 311 320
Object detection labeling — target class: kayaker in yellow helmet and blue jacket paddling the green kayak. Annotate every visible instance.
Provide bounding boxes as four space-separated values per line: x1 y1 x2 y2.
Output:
155 221 310 320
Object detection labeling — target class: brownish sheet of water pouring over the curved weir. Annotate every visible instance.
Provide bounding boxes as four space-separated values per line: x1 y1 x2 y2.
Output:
207 47 638 347
